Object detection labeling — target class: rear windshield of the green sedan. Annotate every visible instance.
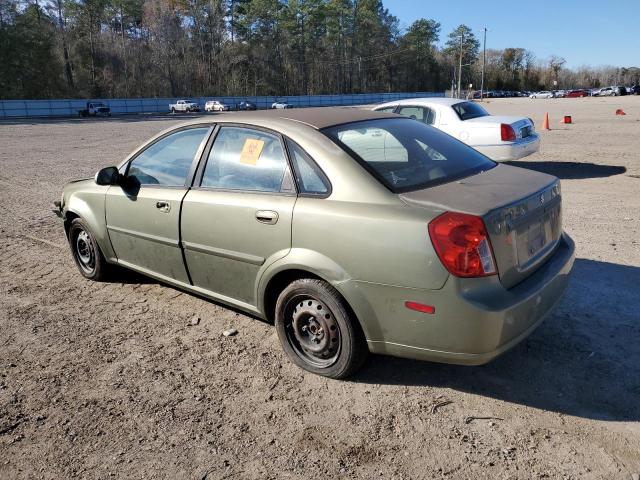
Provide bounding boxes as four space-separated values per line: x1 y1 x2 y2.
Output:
323 118 496 193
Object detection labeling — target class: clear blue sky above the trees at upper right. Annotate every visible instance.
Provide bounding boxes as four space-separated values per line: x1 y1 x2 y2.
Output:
383 0 640 67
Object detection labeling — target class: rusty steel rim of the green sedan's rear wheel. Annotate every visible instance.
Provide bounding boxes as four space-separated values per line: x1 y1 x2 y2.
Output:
285 295 342 368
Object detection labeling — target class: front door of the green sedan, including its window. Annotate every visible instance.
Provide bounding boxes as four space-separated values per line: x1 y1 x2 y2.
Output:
105 126 211 283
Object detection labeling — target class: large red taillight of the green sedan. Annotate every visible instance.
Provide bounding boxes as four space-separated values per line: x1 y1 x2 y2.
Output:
429 212 497 277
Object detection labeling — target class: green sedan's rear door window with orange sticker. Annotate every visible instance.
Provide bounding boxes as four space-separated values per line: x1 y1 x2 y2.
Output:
201 127 292 192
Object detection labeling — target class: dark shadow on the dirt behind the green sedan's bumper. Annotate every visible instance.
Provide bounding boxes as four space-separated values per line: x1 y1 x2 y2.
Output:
352 259 640 421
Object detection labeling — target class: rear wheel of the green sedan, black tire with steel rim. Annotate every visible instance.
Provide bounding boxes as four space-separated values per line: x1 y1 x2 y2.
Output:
275 278 369 378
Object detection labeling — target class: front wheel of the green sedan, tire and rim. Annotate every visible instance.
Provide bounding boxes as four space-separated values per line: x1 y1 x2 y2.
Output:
69 218 109 282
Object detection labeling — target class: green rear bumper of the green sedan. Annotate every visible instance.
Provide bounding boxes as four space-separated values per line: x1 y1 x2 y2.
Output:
354 234 575 365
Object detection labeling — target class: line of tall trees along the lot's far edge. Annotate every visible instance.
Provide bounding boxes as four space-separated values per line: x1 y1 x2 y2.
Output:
0 0 639 99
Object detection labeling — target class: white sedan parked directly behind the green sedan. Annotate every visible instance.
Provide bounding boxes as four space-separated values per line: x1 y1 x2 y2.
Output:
373 98 540 161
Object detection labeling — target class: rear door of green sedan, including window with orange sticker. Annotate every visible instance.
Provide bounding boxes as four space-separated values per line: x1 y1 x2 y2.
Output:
182 125 297 306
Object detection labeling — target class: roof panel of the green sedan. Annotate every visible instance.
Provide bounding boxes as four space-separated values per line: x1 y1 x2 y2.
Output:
175 107 398 130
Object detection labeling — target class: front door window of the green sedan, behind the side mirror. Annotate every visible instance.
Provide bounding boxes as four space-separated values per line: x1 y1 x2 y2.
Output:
127 127 209 187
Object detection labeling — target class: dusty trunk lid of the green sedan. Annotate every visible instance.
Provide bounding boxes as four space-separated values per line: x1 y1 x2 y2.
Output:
400 164 562 288
